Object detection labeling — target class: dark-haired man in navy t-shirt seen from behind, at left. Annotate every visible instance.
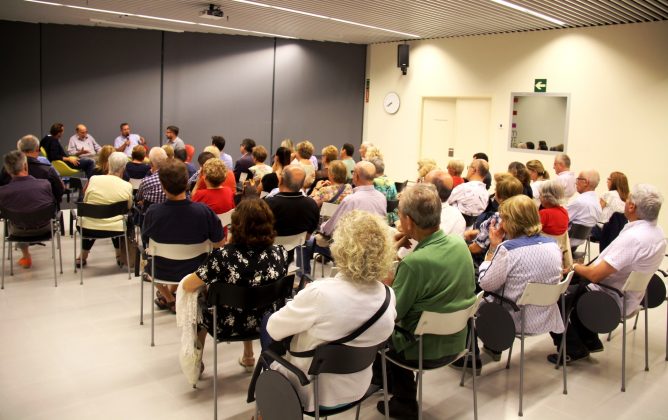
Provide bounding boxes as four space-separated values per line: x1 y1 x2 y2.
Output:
141 159 223 312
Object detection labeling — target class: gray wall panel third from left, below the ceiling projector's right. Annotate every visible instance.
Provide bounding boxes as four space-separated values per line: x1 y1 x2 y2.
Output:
163 33 274 160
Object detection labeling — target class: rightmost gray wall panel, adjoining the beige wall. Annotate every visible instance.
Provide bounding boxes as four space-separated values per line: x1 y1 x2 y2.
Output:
274 39 366 158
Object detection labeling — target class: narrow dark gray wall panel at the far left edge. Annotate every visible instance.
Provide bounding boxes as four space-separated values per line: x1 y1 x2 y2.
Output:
0 22 42 154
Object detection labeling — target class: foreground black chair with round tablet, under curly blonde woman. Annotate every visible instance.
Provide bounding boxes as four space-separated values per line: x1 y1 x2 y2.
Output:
248 344 388 420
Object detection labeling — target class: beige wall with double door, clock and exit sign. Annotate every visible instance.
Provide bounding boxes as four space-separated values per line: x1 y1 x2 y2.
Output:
363 22 668 232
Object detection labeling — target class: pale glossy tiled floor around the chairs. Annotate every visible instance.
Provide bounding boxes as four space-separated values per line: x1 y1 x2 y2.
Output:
0 221 668 420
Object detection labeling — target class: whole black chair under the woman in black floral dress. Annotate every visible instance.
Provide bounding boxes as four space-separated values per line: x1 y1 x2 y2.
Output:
207 274 295 419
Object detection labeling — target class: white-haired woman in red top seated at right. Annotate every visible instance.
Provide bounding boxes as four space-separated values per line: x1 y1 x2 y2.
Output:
538 179 573 272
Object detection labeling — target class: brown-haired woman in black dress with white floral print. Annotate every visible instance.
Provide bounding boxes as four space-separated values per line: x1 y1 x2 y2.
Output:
183 199 288 369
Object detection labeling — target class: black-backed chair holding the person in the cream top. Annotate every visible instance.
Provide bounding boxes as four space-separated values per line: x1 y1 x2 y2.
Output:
74 201 132 284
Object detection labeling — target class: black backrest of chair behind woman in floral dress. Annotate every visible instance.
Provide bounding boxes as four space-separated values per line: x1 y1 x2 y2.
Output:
207 274 295 310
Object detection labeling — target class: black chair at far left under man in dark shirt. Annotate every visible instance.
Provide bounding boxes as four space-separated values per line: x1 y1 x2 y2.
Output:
0 204 63 289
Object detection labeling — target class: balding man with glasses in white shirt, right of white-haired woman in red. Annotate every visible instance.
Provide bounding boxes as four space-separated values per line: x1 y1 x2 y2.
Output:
566 170 603 248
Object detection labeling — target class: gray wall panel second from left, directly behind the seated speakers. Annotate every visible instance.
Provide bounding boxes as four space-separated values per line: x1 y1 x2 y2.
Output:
42 25 161 147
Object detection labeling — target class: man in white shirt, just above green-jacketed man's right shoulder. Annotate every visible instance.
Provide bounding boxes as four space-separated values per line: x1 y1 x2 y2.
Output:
448 159 489 226
